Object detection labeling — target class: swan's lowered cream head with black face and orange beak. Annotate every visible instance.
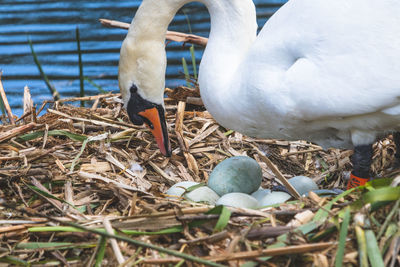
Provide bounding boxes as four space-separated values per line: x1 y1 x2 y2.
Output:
118 34 171 156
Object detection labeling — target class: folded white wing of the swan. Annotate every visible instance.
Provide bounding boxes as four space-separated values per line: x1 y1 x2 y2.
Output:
245 0 400 121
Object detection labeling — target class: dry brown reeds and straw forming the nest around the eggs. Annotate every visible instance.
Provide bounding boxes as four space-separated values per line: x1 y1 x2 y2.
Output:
0 87 395 266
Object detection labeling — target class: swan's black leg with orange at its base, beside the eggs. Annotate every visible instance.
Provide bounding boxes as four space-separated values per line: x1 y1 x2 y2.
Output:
347 144 373 189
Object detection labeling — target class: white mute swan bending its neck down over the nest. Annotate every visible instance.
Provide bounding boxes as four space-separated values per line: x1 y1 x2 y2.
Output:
118 0 400 191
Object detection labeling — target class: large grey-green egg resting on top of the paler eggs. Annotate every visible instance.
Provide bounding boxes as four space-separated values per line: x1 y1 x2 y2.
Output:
208 156 262 196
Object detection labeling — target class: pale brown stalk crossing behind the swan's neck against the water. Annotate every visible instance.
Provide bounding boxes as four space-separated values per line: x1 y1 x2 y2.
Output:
99 19 208 46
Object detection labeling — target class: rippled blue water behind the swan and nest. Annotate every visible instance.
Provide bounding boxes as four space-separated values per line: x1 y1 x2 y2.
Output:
0 0 286 115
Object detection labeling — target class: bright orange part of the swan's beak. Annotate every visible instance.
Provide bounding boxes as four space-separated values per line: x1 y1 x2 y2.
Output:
138 107 171 157
